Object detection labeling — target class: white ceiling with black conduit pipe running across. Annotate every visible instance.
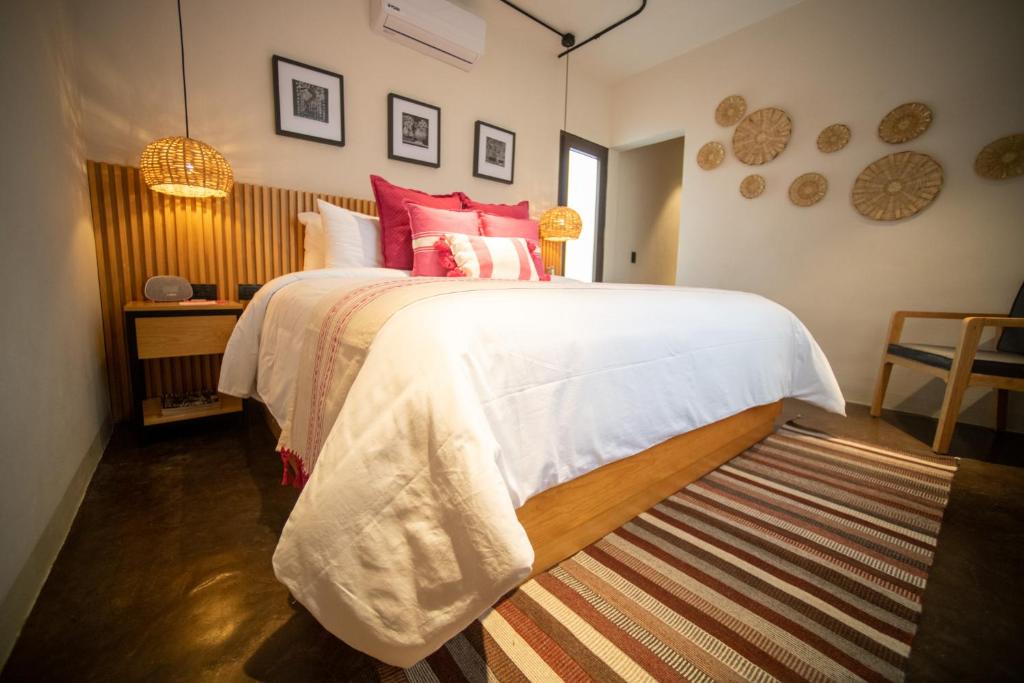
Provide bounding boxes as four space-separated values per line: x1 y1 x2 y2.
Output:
506 0 801 82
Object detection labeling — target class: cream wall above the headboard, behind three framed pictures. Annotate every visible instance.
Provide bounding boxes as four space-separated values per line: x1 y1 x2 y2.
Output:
76 0 609 213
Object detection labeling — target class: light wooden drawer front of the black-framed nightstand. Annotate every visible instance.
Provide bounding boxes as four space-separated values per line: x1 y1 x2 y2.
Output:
135 315 239 359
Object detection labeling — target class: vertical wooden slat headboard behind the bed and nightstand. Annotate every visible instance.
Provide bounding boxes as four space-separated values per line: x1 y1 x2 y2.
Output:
88 161 562 421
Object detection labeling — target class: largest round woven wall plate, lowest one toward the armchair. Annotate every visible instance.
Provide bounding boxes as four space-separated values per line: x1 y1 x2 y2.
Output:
850 152 942 220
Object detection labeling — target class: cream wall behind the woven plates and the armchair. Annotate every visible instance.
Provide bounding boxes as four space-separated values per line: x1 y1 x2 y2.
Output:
612 0 1024 429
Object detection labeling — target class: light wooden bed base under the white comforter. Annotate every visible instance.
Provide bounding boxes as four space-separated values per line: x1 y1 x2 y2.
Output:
260 400 782 577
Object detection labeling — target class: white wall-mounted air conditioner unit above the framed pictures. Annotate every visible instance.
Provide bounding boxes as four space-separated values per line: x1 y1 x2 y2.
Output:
370 0 487 71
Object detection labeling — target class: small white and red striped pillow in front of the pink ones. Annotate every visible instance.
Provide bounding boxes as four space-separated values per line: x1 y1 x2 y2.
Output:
434 233 551 281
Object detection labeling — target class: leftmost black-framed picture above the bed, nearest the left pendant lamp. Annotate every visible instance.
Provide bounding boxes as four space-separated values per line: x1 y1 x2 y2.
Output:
271 54 345 146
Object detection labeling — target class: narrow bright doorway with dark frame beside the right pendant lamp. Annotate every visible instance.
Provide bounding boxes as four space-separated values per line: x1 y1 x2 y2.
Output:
558 130 608 283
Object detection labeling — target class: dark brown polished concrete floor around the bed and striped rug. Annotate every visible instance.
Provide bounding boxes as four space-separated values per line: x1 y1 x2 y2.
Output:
2 401 1024 681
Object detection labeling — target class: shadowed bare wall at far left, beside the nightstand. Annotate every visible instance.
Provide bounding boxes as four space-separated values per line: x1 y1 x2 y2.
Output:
0 0 110 663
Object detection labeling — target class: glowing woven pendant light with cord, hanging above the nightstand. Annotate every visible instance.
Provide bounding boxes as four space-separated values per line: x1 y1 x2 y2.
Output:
138 0 234 199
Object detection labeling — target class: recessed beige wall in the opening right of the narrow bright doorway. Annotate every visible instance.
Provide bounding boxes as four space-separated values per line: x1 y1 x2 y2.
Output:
603 137 684 285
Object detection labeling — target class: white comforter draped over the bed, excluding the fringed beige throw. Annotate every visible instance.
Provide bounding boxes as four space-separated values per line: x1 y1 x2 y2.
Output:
220 269 845 666
